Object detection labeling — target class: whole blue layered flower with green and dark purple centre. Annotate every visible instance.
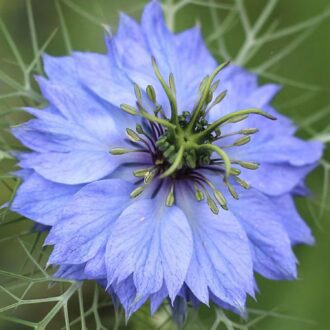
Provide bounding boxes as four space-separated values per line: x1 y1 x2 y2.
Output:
12 1 322 318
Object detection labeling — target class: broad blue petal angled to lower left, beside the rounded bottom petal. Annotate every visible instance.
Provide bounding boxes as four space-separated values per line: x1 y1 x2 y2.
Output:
46 179 133 264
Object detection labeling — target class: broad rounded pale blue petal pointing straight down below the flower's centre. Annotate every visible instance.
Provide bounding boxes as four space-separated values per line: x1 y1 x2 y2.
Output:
106 198 192 300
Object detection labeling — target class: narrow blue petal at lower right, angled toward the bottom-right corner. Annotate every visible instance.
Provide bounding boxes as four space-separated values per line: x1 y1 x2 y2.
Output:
228 188 297 280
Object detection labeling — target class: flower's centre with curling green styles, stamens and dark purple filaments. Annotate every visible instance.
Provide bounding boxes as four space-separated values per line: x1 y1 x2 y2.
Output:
110 58 276 214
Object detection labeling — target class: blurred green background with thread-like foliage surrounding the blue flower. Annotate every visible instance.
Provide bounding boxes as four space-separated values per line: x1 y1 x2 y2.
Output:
0 0 330 330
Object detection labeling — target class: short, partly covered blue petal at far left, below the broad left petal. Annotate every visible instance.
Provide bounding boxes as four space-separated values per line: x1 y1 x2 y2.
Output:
11 173 82 226
